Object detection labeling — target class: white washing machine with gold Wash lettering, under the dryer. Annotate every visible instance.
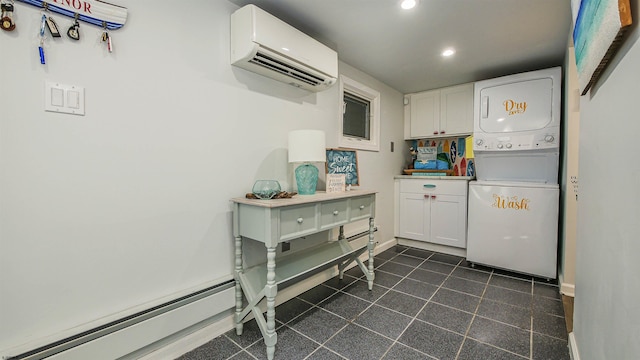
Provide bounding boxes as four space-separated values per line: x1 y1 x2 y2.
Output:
467 181 560 279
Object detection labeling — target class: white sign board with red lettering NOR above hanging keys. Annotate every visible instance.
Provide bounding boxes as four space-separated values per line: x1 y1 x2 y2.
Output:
17 0 127 30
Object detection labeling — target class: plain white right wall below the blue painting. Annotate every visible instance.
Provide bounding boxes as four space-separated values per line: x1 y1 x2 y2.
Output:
574 0 640 360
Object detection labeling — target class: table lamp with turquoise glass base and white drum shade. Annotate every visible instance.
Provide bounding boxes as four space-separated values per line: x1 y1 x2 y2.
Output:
289 130 327 195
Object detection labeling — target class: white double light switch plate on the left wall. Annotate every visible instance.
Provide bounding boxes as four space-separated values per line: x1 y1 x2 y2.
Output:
44 81 84 115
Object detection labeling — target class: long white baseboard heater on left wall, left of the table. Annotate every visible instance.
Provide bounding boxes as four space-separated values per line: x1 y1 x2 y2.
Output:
3 280 235 360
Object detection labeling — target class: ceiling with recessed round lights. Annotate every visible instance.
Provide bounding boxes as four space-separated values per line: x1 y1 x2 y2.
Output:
229 0 571 94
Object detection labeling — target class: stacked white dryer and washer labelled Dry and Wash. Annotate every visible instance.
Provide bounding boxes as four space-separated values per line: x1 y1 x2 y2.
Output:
467 67 562 279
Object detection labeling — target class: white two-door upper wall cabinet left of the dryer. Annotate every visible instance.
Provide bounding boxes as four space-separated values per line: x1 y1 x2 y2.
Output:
404 83 473 139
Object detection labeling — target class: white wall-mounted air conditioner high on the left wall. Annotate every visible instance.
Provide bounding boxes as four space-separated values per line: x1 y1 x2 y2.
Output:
231 5 338 91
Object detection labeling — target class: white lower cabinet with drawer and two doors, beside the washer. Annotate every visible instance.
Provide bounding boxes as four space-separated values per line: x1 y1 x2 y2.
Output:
396 179 468 248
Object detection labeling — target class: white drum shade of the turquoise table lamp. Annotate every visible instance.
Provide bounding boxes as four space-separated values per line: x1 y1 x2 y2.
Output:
289 130 327 163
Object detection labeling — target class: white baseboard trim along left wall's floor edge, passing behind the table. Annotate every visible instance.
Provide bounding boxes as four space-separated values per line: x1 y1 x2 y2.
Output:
138 238 398 360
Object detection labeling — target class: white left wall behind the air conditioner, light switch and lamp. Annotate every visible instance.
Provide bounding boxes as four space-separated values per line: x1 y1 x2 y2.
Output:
0 0 404 355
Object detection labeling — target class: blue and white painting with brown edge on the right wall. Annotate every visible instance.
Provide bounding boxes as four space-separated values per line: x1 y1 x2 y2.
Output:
571 0 631 95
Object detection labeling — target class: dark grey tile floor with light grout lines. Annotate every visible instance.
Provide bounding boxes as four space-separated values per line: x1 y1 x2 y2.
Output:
179 246 569 360
